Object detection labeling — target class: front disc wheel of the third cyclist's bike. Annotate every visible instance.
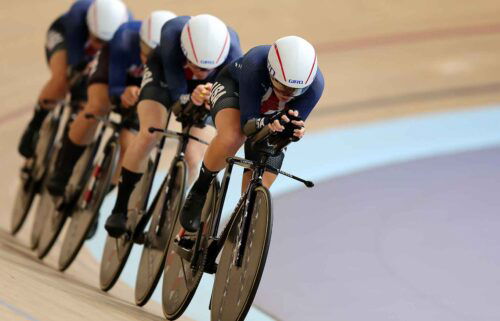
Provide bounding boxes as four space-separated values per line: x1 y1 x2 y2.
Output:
58 140 120 271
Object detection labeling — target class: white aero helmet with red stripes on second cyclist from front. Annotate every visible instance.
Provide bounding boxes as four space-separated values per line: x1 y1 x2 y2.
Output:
181 14 231 69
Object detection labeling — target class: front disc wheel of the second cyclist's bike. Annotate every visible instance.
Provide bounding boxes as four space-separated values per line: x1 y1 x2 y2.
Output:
135 160 187 306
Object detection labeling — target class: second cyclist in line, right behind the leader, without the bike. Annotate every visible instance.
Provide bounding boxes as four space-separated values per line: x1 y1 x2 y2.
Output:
105 14 242 237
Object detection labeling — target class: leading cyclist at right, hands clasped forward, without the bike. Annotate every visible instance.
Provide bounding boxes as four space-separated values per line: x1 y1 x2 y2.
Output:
179 36 324 234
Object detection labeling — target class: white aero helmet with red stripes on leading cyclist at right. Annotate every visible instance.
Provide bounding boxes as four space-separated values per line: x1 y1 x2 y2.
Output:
267 36 318 96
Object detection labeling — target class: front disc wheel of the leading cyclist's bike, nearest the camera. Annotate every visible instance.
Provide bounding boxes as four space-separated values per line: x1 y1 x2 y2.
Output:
211 186 272 321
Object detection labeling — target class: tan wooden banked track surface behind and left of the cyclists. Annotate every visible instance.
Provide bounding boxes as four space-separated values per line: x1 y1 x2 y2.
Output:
0 0 500 320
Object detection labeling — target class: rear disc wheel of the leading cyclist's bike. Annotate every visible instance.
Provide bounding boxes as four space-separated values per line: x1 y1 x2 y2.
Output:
162 180 219 320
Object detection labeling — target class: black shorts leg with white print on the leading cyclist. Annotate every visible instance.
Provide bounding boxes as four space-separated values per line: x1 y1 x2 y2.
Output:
210 65 240 122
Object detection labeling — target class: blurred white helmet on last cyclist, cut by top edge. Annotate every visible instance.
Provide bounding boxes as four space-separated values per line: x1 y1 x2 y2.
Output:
87 0 129 41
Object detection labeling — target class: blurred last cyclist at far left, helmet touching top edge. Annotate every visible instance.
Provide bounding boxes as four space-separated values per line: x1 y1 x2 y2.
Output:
18 0 129 158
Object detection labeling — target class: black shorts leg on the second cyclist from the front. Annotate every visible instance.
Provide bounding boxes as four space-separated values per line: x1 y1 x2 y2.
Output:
139 48 172 108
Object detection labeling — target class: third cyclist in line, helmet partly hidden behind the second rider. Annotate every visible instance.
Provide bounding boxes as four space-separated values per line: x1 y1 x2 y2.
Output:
47 11 175 200
